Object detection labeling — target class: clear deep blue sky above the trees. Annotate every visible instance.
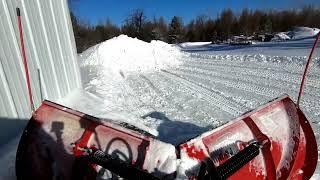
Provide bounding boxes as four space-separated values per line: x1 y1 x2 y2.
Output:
71 0 320 25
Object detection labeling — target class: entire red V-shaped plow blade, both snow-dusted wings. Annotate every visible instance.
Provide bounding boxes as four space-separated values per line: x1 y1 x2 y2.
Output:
16 96 318 179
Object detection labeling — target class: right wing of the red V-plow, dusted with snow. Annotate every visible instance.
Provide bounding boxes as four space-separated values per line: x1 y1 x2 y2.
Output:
180 96 318 179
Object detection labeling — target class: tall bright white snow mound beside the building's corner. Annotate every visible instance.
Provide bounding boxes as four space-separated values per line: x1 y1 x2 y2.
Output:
80 35 182 77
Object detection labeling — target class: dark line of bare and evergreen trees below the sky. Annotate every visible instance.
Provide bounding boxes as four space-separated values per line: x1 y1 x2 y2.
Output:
71 6 320 52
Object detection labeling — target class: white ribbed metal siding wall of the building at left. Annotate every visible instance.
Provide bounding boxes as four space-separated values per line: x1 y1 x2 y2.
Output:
0 0 81 118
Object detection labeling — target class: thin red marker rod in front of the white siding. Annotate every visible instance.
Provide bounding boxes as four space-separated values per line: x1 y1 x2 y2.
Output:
17 8 35 112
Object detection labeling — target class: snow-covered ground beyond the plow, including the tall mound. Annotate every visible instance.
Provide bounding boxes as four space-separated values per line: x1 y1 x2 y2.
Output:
0 32 320 179
